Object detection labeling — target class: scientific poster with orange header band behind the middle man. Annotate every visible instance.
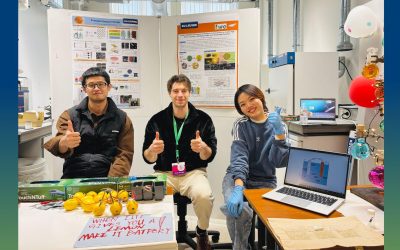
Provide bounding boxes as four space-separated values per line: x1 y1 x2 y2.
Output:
177 20 239 107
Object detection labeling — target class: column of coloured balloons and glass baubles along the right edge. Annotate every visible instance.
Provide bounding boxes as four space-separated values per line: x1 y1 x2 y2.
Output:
344 5 384 189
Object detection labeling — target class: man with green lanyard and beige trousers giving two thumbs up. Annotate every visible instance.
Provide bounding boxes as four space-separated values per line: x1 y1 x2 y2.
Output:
142 74 217 250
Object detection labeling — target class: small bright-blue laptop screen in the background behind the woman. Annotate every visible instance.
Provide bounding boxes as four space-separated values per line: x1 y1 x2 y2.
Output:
300 98 336 120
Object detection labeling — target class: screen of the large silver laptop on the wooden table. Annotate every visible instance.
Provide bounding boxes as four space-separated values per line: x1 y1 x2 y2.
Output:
285 147 350 198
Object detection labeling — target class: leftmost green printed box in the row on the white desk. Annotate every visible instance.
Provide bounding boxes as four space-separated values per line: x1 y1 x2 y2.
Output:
18 179 75 202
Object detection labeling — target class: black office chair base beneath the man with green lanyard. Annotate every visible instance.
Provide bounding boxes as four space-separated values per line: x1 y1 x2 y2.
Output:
174 193 224 249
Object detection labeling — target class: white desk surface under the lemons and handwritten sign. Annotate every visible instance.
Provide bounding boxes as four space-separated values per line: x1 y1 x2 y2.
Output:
18 195 178 250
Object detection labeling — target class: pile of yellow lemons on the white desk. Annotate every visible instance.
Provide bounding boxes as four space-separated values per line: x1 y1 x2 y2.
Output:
64 189 139 216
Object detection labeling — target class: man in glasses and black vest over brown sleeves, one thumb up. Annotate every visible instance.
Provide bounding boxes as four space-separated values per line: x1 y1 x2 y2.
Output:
44 67 133 178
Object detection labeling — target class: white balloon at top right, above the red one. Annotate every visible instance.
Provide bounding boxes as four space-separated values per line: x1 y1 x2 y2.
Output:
344 5 378 38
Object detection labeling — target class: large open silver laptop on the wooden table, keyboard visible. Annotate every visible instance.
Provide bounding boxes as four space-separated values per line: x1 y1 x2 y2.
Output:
262 147 350 215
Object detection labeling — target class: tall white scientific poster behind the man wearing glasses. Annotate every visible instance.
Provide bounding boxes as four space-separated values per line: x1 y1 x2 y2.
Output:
71 15 141 108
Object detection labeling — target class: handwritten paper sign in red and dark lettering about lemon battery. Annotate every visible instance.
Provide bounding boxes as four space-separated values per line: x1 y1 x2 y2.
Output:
74 213 175 248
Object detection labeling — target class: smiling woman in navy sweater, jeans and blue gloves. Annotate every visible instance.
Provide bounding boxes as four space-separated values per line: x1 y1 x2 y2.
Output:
221 84 289 250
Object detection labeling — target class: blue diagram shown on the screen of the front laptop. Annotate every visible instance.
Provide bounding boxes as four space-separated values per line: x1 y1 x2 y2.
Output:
301 158 329 186
